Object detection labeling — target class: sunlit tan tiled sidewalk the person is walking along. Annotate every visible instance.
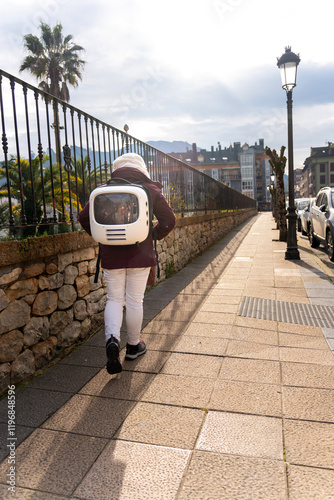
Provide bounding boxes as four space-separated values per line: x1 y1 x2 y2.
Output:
0 213 334 500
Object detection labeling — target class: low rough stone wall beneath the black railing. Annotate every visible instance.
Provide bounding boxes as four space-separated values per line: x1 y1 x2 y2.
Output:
0 210 255 393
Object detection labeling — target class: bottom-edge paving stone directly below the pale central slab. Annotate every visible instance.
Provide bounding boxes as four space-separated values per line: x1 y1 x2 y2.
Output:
177 451 288 500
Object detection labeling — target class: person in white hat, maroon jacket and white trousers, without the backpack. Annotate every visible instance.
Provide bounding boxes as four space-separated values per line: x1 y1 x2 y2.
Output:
78 153 176 375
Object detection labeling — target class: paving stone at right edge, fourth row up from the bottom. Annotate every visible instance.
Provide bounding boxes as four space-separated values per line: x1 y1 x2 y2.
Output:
281 362 334 389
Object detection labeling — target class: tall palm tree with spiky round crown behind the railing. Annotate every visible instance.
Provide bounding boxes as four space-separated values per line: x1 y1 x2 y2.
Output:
20 22 85 164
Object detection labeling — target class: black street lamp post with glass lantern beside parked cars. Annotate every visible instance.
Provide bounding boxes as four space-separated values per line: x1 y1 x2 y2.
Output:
277 47 300 260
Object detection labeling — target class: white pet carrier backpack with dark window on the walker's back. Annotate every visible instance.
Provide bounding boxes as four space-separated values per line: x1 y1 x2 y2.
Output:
89 178 153 245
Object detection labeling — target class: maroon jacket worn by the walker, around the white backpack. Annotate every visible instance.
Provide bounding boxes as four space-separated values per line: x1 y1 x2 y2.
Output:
78 167 176 269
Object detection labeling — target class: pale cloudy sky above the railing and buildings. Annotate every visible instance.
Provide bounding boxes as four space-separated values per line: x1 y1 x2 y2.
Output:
0 0 334 168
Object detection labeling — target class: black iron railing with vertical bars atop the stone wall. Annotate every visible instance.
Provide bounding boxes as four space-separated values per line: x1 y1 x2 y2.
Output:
0 70 256 236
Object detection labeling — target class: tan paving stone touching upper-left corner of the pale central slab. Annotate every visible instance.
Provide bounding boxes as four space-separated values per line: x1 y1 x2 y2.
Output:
141 374 214 408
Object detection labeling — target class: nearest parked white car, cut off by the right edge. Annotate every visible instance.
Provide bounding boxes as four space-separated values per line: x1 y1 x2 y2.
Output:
310 187 334 261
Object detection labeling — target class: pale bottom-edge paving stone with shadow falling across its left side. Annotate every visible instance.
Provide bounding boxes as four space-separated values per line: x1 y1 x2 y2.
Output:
74 441 190 500
